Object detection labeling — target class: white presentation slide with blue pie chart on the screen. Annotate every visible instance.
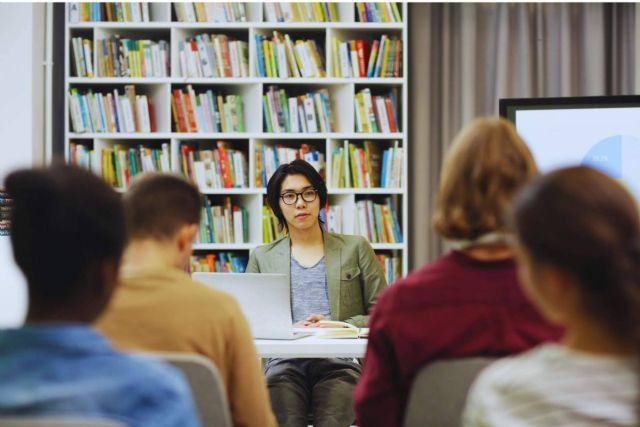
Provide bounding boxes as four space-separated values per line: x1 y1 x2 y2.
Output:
516 107 640 201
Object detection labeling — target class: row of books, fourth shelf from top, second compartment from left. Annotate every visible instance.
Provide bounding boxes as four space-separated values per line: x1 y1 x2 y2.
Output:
180 141 249 189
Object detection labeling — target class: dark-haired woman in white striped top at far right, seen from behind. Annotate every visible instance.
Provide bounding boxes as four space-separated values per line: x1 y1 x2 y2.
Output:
464 166 640 427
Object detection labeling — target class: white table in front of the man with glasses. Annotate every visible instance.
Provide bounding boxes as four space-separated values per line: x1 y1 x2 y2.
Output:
254 335 367 358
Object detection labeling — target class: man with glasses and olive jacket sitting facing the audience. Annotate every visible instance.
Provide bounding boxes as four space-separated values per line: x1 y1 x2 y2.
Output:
247 160 386 427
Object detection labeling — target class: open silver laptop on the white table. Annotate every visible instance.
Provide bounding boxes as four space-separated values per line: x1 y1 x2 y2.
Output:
191 273 310 340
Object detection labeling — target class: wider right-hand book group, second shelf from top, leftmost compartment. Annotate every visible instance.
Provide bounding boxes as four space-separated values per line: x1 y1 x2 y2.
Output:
95 35 171 77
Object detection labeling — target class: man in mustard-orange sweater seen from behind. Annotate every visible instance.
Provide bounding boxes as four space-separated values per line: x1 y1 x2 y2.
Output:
96 174 276 427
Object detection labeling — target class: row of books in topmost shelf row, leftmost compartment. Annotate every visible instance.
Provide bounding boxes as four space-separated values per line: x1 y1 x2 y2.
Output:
69 1 151 23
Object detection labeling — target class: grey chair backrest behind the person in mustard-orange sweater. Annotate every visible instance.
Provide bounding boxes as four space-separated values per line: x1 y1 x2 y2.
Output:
149 353 233 427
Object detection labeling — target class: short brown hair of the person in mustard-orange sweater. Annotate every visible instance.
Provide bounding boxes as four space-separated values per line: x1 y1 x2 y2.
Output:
122 173 203 239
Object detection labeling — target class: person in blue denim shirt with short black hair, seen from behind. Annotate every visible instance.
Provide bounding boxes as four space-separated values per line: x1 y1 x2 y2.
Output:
0 166 200 427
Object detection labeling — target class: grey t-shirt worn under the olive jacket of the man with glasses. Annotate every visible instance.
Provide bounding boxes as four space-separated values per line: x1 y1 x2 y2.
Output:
291 257 331 323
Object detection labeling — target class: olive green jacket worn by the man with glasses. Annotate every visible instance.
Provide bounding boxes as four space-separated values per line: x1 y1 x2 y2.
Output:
246 230 387 328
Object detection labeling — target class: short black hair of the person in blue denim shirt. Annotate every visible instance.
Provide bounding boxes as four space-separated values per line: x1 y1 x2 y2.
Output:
5 165 126 302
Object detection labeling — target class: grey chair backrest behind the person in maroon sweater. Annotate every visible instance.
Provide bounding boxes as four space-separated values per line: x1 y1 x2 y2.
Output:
404 357 496 427
